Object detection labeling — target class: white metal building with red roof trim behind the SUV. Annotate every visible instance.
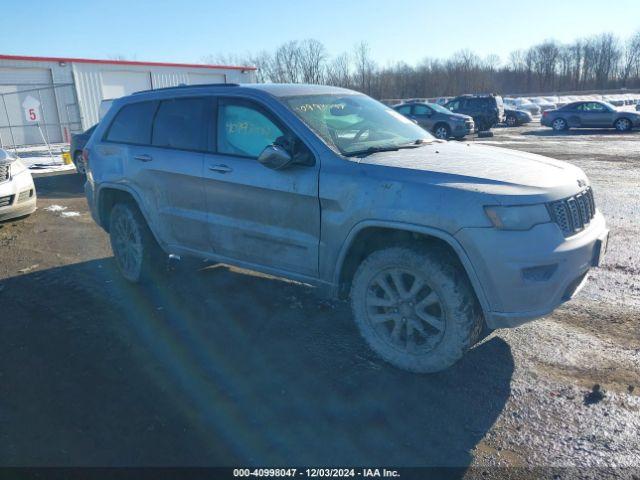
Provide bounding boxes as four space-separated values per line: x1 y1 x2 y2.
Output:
0 55 256 147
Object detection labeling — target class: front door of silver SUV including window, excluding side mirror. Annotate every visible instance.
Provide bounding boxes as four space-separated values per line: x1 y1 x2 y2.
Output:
205 98 320 276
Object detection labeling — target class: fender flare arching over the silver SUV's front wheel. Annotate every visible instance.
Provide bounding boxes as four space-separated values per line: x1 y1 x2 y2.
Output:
333 220 491 320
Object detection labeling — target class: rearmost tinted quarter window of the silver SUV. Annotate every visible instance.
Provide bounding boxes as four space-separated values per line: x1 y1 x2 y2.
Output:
106 102 158 145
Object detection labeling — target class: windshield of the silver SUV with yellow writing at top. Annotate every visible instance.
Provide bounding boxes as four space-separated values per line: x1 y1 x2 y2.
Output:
284 94 433 155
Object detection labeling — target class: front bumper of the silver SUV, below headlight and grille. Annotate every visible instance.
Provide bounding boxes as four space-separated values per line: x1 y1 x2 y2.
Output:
456 212 609 328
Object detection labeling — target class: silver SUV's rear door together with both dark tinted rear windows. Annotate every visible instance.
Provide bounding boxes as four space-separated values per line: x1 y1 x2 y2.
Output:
106 98 211 249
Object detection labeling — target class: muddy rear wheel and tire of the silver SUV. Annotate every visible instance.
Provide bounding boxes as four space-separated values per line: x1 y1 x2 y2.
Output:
109 202 167 283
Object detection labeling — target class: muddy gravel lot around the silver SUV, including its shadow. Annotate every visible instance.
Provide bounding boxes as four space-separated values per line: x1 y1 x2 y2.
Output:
0 121 640 469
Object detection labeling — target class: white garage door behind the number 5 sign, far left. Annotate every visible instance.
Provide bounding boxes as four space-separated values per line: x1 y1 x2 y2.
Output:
0 67 62 145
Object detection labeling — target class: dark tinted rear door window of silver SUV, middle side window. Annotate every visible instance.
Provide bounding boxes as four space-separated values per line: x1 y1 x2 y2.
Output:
151 98 211 151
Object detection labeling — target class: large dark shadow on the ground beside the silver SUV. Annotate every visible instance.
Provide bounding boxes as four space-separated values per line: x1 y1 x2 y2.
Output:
0 259 514 467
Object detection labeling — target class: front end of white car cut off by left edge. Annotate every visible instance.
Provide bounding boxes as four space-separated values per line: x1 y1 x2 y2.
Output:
0 149 36 221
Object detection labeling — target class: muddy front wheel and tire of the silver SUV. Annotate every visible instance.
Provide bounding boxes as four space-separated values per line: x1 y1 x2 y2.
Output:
351 247 484 373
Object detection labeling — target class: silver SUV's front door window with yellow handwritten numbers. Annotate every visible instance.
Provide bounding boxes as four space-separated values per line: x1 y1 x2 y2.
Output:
218 100 284 158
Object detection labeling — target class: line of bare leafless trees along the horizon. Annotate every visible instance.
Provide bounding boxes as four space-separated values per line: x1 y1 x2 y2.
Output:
203 30 640 99
